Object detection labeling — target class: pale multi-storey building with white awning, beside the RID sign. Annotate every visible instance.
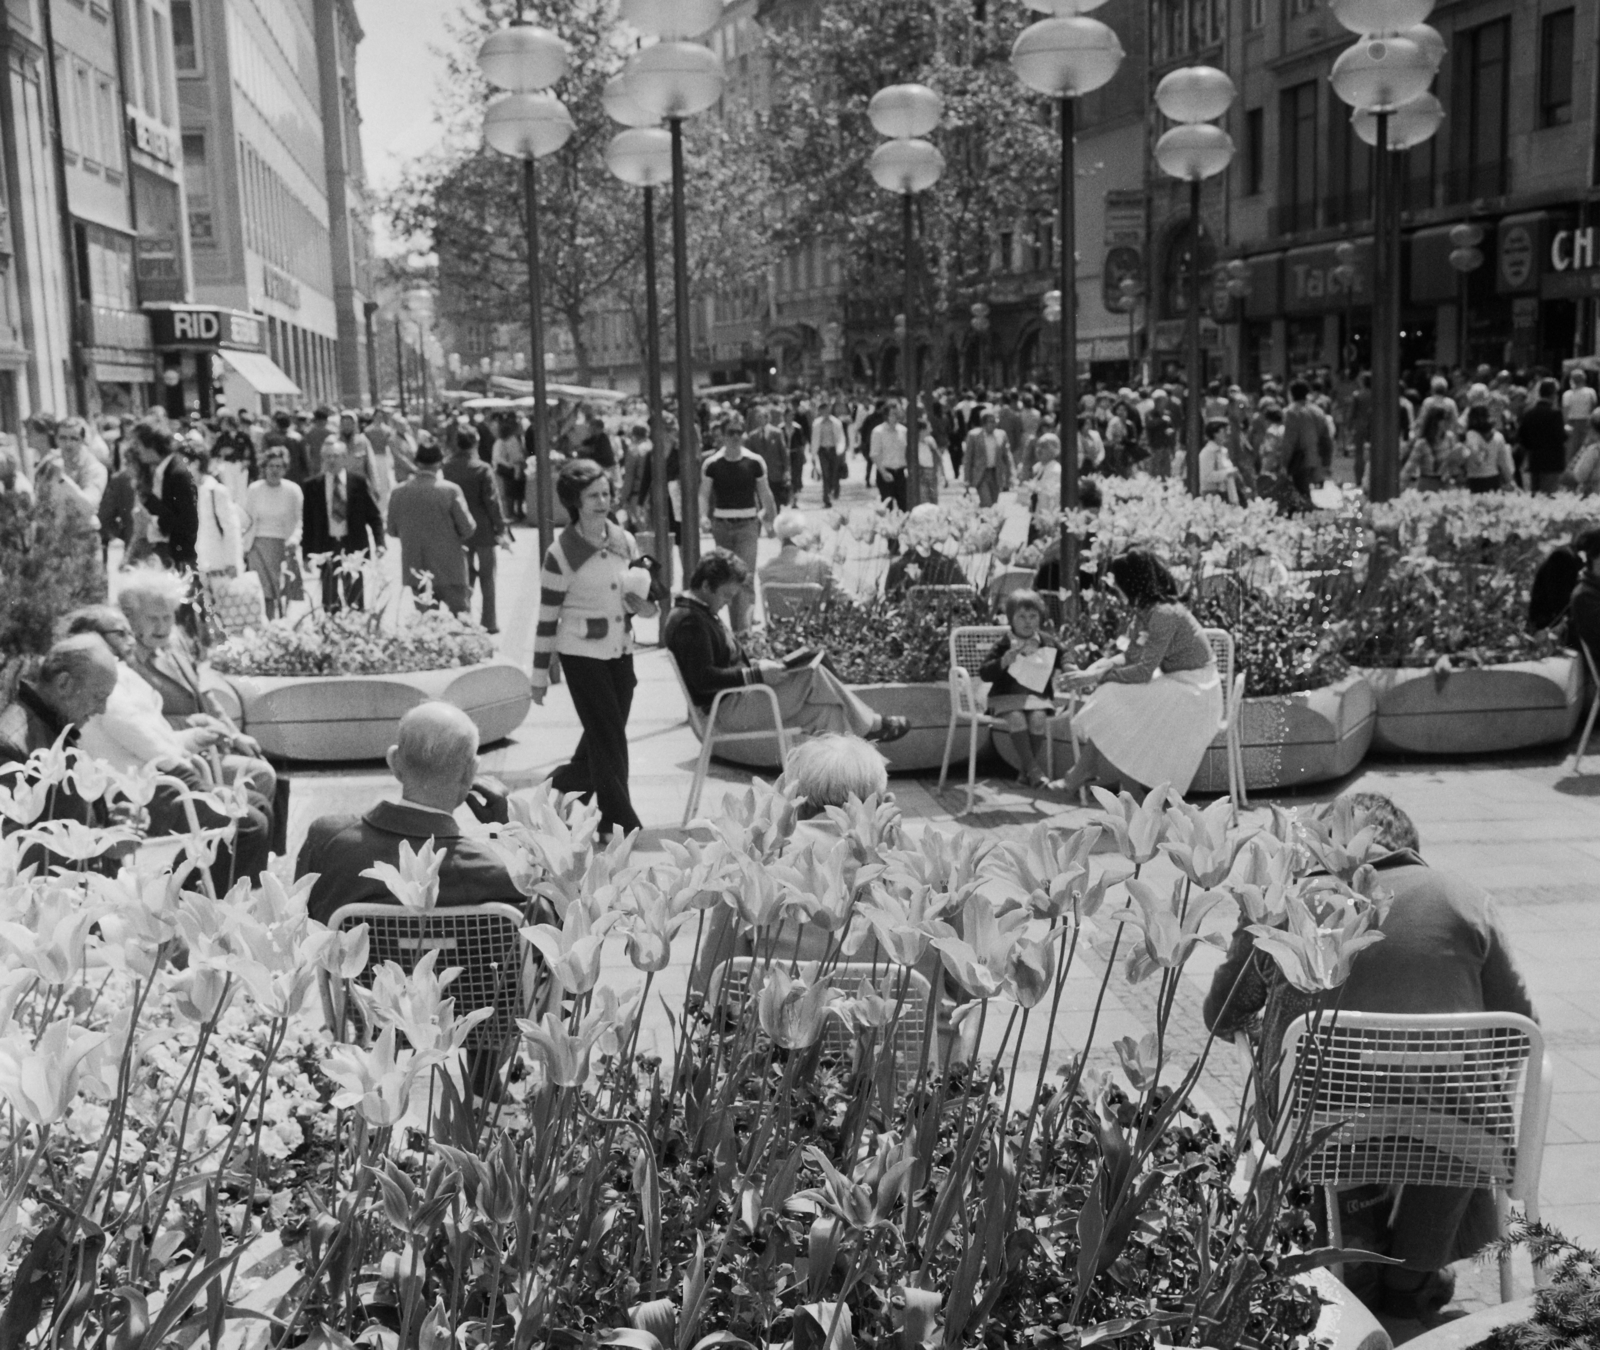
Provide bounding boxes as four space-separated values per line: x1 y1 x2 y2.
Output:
168 0 368 406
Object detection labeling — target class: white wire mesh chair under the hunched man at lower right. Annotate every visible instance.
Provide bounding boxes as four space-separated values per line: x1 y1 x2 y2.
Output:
1278 1013 1554 1300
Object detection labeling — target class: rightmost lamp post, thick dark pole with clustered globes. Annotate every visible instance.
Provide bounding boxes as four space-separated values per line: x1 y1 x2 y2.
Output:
1328 0 1445 501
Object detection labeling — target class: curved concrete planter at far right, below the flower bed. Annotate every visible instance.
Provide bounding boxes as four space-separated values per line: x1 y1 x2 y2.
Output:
1363 656 1584 755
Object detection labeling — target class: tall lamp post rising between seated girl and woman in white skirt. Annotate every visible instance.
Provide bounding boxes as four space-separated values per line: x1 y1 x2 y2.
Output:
1011 0 1123 598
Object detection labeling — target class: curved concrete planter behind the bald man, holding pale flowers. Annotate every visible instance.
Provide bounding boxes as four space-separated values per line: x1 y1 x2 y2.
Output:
232 661 533 760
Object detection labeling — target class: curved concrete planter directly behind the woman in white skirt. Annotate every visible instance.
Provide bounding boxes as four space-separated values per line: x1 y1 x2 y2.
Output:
994 673 1378 793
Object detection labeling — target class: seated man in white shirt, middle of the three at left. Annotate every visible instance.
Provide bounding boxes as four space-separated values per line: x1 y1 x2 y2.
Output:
67 605 272 894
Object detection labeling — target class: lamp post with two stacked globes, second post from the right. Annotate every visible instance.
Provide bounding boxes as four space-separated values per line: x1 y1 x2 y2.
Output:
1155 66 1234 496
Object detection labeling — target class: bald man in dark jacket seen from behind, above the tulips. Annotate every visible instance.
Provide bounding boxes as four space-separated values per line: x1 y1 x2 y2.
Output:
294 702 525 923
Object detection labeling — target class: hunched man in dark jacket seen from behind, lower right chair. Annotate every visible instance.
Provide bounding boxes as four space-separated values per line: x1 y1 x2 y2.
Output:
1203 793 1534 1318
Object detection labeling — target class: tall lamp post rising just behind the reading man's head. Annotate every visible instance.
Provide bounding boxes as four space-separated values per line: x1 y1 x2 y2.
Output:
622 0 723 579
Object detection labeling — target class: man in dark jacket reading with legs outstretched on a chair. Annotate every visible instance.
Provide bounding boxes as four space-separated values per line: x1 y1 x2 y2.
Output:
661 550 910 741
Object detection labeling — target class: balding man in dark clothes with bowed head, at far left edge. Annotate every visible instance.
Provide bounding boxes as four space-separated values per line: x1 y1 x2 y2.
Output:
0 633 126 875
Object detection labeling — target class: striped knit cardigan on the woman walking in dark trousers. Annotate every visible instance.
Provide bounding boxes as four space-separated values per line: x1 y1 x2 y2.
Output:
533 523 638 689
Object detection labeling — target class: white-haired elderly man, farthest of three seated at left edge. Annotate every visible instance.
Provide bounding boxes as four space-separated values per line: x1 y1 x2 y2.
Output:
117 568 278 803
